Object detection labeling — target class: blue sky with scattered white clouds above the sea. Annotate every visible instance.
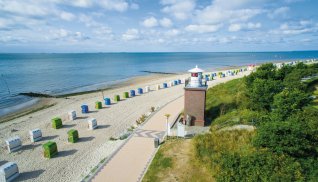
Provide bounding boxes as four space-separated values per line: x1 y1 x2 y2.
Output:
0 0 318 53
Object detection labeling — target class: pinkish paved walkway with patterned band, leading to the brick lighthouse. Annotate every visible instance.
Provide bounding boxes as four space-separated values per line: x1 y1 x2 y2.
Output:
92 97 184 182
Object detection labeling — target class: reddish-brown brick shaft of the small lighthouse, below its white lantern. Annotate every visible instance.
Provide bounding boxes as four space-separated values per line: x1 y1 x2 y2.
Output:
184 88 206 126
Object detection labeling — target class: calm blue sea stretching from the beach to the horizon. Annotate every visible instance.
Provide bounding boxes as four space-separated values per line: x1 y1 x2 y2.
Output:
0 51 318 115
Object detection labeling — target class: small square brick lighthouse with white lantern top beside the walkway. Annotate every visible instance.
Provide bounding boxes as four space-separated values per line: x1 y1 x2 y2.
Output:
184 66 207 126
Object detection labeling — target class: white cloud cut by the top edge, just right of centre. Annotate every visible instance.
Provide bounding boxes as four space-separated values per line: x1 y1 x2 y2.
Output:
161 0 195 20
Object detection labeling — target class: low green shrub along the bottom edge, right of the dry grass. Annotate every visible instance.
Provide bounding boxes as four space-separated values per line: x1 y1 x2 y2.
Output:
215 152 304 181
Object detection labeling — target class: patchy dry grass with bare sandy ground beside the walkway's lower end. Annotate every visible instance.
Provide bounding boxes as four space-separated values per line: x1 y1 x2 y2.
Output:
142 139 215 182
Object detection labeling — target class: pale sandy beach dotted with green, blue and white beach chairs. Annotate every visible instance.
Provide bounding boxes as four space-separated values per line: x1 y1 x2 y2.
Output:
0 67 249 182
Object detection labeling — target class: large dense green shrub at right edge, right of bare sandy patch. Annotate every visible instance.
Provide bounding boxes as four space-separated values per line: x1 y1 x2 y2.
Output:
253 108 318 158
